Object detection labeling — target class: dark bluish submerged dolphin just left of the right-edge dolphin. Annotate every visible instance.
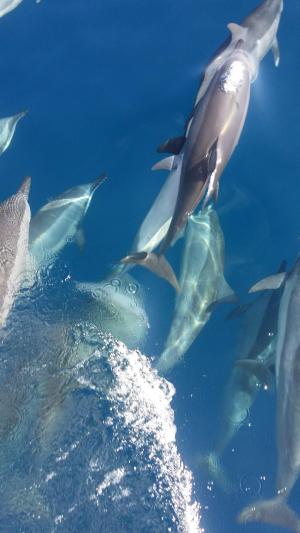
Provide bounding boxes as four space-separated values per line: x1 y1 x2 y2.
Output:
198 261 286 492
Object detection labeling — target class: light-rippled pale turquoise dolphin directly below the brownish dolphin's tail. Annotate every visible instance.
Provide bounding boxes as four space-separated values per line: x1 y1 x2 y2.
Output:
156 207 234 374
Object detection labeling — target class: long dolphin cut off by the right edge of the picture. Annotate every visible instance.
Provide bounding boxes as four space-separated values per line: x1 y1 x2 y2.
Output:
238 258 300 533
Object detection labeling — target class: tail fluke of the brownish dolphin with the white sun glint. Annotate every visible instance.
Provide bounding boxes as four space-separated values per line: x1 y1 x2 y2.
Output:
121 252 180 292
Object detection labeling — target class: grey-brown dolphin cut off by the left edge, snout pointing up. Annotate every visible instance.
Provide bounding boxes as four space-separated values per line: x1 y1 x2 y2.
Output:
0 178 31 327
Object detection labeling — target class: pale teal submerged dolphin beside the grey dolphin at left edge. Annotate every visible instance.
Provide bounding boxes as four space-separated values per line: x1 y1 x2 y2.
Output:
29 175 106 267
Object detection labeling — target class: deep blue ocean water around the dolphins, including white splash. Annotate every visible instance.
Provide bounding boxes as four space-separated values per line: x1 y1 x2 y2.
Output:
0 0 300 533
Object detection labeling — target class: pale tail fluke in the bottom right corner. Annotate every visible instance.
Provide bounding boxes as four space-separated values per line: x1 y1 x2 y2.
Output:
237 497 300 533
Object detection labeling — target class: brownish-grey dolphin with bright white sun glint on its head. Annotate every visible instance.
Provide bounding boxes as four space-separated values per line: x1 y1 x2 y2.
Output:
122 42 252 285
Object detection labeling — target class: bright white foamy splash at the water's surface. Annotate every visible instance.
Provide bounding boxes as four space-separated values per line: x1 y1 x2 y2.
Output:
104 342 204 533
